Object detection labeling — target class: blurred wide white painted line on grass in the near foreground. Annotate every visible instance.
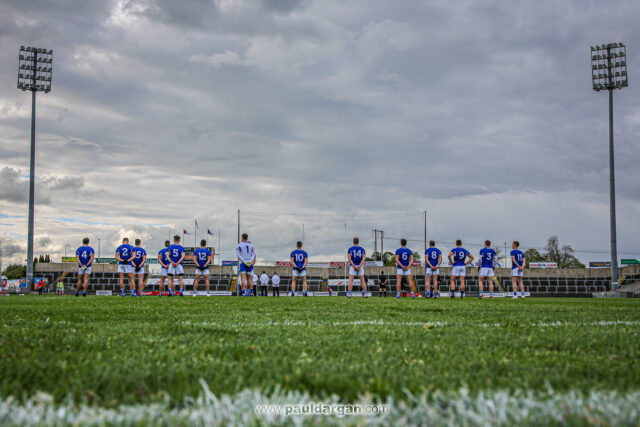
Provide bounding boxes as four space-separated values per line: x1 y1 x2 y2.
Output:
0 386 640 426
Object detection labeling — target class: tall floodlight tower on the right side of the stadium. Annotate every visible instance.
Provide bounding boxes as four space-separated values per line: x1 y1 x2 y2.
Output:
591 43 629 292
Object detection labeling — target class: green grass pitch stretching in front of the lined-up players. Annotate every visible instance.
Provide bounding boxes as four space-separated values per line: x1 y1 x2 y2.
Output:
0 296 640 424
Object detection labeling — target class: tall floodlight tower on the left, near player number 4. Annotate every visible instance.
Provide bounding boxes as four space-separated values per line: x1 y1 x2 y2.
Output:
18 46 53 289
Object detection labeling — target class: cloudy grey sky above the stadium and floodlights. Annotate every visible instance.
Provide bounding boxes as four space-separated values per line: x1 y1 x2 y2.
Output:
0 0 640 265
